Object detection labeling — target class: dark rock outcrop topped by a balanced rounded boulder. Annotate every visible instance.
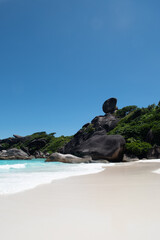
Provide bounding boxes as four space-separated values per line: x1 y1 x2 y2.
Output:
60 98 125 162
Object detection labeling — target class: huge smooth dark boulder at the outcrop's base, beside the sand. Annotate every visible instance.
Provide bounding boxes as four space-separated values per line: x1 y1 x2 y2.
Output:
63 130 125 162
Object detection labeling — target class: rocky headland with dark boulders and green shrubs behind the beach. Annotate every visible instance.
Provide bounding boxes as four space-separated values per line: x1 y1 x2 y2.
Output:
0 98 160 163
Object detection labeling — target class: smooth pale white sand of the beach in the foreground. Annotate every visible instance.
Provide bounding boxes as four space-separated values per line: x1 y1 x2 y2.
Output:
0 162 160 240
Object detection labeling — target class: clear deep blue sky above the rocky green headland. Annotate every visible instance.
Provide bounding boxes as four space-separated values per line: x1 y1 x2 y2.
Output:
0 0 160 138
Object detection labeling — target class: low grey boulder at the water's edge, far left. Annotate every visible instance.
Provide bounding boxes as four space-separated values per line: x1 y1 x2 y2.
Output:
0 148 33 160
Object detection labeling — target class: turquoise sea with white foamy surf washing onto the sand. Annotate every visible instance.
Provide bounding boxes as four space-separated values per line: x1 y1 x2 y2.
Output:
0 159 110 195
